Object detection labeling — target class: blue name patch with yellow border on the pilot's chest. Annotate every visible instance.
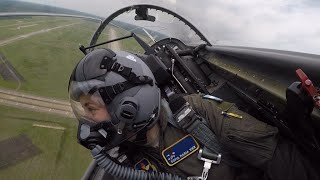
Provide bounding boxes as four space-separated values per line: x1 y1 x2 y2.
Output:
162 134 199 166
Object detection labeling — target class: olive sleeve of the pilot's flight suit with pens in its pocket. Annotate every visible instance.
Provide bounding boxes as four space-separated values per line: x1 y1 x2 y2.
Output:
185 94 278 169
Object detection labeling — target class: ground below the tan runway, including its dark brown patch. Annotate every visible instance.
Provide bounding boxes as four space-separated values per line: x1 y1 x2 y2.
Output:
0 106 91 179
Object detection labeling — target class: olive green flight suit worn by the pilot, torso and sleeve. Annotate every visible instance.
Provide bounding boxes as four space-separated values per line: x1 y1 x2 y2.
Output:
126 94 318 180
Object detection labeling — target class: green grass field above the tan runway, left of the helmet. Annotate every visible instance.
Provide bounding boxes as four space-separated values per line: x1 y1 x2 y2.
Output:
0 17 98 99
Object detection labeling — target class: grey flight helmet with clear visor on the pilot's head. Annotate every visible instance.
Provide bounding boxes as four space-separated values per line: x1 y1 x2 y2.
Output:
68 49 160 148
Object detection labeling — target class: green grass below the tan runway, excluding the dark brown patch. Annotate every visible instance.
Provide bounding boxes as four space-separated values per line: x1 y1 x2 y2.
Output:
0 106 92 179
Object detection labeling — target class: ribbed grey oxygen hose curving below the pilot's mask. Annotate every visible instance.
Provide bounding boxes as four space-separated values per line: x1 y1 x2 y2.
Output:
91 145 182 180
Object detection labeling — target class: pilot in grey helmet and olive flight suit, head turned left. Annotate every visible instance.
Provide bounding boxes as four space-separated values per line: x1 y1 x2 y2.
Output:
69 49 318 180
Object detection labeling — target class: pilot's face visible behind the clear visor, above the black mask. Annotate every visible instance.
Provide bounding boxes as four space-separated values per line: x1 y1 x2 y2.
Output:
79 95 111 122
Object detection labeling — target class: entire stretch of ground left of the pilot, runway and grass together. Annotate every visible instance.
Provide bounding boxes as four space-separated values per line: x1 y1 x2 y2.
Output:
0 17 98 179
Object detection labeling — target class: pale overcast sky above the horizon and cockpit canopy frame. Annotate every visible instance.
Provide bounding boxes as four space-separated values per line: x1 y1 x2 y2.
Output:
19 0 320 54
